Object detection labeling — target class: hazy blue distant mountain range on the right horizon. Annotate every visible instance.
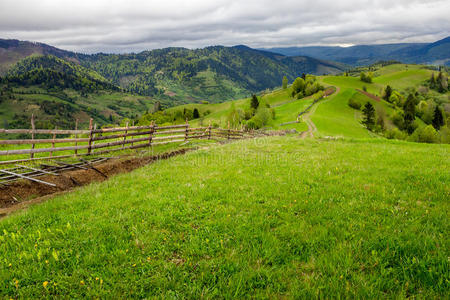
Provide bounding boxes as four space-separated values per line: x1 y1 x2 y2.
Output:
261 37 450 66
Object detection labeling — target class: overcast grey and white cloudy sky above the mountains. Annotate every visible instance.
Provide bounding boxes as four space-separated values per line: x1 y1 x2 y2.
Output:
0 0 450 53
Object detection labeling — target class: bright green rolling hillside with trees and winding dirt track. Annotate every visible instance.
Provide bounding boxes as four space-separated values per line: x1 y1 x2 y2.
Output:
153 64 450 142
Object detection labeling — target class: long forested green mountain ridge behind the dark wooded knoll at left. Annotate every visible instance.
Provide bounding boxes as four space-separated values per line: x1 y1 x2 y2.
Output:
0 40 347 102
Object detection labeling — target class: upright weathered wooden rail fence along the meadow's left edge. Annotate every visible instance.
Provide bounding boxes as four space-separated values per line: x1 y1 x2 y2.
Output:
0 119 254 165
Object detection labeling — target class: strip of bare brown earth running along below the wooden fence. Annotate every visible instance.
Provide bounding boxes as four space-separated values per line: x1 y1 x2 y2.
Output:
0 149 191 211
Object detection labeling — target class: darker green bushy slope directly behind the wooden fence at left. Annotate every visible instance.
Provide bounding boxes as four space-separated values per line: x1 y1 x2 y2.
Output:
0 84 160 129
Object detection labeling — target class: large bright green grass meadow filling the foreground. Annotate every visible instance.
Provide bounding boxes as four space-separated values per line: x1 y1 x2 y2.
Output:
0 137 450 299
